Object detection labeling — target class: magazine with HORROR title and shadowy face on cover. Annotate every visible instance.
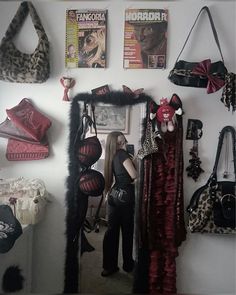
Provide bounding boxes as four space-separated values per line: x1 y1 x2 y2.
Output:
123 9 168 69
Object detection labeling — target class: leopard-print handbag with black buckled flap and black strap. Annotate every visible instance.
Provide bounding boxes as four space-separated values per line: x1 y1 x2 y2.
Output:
187 126 236 234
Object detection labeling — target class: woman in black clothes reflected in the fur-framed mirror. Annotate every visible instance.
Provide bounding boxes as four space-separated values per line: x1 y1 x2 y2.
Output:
101 131 137 277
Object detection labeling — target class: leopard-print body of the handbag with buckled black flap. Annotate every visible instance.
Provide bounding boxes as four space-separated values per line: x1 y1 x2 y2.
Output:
188 186 236 234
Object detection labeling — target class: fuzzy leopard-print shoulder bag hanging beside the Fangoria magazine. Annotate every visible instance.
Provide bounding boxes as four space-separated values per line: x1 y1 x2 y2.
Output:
0 1 50 83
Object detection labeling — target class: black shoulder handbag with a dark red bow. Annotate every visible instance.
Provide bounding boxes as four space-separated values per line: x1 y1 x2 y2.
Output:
168 6 228 94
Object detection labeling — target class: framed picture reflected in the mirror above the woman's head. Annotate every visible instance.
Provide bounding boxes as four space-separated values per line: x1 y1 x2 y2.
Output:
90 104 130 134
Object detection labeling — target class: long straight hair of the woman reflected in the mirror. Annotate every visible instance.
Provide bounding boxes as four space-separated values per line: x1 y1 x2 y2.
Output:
104 131 123 194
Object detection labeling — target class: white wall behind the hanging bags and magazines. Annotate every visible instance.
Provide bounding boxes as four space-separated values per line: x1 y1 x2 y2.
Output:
0 0 236 295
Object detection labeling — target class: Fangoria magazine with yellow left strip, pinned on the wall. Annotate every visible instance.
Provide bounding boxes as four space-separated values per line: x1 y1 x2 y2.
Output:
65 10 107 68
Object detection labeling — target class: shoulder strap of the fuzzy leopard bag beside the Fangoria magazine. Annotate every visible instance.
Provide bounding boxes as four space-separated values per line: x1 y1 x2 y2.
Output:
5 1 47 40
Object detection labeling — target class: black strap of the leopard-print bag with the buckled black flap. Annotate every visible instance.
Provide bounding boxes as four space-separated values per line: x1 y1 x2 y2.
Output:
208 126 236 185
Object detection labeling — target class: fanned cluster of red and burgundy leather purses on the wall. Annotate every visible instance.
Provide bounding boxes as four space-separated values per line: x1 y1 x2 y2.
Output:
0 98 51 161
